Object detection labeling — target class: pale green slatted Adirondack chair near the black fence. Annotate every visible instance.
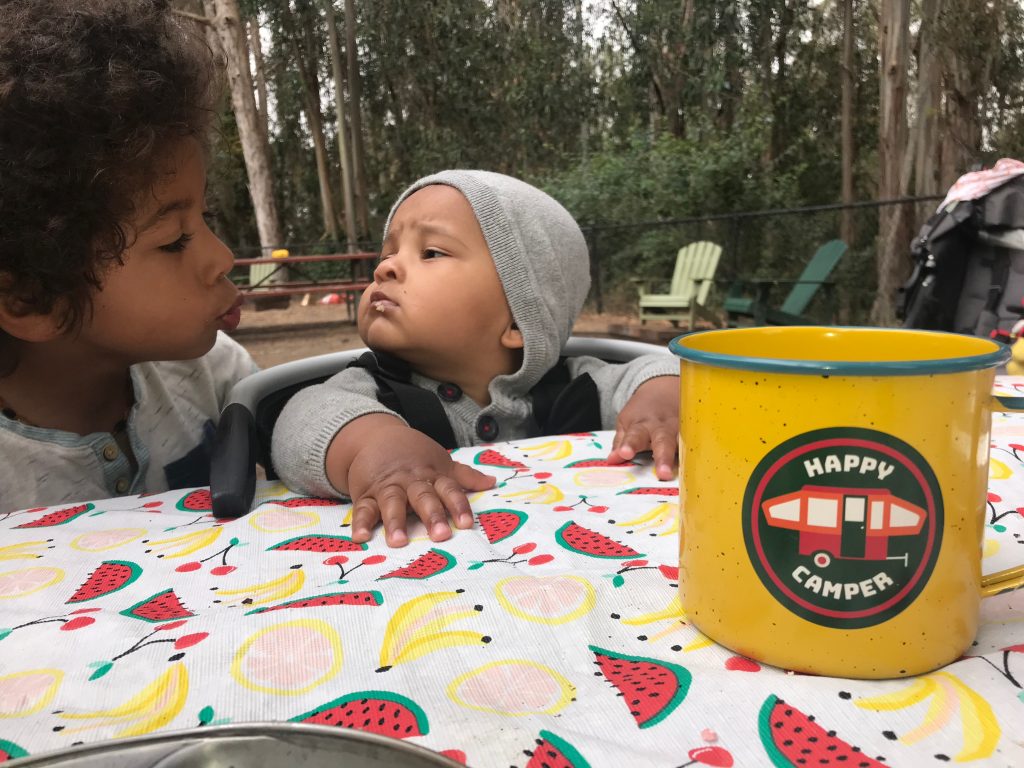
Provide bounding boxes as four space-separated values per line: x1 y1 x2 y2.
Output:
633 240 722 329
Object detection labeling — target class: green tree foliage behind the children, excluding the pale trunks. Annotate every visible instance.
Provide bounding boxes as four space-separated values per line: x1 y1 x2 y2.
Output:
203 0 1024 321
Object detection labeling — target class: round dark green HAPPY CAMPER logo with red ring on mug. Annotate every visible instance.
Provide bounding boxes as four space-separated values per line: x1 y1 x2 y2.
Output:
743 428 943 629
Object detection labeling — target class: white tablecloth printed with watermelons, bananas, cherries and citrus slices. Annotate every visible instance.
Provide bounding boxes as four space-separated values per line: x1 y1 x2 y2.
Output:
0 423 1024 768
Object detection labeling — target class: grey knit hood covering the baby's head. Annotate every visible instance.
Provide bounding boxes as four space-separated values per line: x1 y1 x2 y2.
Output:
384 171 590 392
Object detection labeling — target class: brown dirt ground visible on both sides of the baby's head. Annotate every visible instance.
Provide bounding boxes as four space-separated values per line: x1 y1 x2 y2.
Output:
233 298 663 368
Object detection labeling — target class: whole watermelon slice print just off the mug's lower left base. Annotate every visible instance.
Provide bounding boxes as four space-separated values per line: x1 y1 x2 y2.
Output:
589 645 693 728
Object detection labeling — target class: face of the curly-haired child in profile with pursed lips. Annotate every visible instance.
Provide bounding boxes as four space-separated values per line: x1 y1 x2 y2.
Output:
80 139 241 362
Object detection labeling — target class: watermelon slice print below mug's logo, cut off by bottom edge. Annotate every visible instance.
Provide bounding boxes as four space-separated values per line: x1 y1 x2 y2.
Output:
758 695 885 768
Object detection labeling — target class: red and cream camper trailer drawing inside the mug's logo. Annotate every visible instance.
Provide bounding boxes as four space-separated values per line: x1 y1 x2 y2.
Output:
761 485 928 568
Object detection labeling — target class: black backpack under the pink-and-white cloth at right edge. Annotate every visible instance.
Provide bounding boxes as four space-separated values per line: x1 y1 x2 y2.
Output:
896 176 1024 341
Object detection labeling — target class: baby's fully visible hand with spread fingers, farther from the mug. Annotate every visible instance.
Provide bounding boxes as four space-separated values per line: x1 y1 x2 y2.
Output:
335 417 495 547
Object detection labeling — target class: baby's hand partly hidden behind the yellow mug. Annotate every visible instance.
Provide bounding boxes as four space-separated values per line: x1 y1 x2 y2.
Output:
608 376 679 480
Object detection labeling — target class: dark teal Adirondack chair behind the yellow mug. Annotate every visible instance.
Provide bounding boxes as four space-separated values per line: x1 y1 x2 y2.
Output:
723 240 848 326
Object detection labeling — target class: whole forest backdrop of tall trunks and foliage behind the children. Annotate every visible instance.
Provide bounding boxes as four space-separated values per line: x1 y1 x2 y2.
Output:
180 0 1024 325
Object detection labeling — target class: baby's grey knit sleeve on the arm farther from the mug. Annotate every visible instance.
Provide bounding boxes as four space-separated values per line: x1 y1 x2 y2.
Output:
271 368 404 497
